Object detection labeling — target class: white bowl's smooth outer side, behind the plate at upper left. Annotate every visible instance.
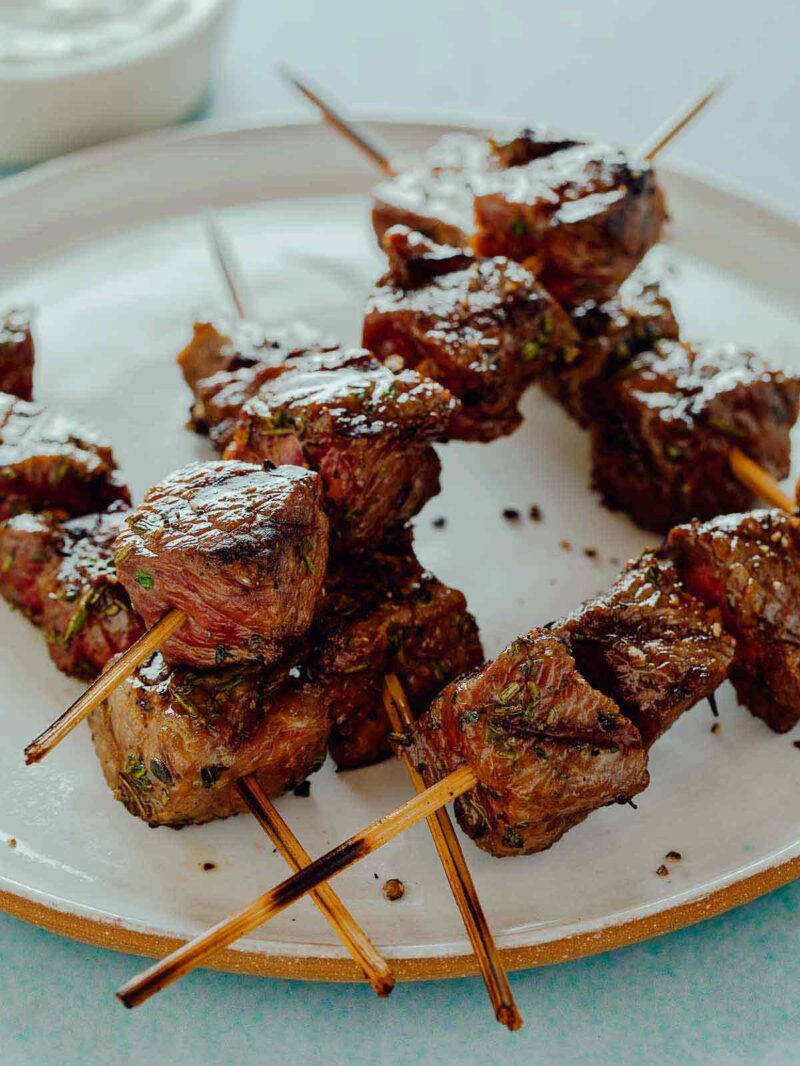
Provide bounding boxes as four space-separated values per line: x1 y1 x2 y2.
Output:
0 0 231 166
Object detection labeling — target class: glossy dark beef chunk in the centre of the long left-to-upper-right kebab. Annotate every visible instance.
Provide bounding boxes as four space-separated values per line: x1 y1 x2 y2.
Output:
363 226 577 440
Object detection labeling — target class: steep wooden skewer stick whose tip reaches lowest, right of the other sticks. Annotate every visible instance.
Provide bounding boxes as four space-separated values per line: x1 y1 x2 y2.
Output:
383 674 523 1032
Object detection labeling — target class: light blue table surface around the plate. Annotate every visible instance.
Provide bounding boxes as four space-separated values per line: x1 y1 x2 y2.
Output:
0 0 800 1066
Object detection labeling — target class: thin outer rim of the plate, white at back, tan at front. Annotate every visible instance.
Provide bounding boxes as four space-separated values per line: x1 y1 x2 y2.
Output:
0 109 800 983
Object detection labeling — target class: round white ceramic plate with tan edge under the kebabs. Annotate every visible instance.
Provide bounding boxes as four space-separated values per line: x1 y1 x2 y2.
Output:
0 122 800 979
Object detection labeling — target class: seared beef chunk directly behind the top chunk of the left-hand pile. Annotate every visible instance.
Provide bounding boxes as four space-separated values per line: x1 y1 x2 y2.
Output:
225 350 458 550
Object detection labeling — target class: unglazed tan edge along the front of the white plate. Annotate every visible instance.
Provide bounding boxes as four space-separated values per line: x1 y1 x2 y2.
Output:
0 856 800 983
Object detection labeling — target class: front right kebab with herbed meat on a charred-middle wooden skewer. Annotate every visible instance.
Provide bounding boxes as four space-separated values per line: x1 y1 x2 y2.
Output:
119 501 800 1006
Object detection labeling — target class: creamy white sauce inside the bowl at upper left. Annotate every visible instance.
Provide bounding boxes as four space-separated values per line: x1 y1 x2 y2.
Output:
0 0 209 70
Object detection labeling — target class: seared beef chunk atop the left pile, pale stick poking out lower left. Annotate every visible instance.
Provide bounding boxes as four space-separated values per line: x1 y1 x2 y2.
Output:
116 462 329 666
